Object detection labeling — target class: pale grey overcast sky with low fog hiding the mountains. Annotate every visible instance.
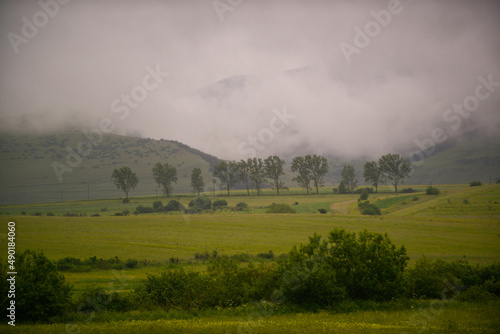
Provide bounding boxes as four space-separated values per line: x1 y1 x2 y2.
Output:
0 0 500 159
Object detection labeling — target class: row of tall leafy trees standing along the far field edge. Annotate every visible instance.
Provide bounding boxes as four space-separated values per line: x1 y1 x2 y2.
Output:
112 154 412 200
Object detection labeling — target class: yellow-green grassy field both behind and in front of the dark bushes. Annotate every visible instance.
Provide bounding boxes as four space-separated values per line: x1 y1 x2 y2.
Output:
0 185 500 333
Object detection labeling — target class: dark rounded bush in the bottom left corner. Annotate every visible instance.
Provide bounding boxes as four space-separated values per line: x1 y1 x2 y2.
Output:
0 249 71 324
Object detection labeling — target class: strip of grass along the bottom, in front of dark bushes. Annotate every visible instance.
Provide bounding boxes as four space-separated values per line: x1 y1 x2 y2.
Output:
0 301 500 334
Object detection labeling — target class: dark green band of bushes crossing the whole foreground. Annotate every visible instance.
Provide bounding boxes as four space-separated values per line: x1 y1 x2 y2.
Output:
0 229 500 322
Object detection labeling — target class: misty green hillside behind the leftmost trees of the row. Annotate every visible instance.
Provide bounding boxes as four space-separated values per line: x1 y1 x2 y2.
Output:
0 131 218 204
